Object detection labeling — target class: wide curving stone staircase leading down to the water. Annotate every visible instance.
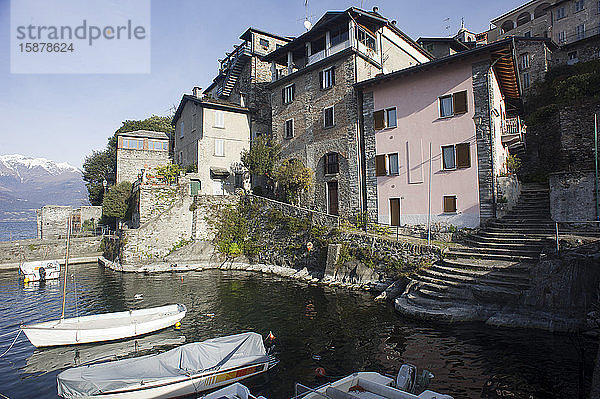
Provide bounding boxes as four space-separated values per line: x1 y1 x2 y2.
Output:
395 185 568 328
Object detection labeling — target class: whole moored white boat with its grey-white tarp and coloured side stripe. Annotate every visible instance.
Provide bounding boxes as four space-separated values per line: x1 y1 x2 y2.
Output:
56 332 277 399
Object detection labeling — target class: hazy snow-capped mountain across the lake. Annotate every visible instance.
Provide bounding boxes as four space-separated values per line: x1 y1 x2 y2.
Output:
0 154 88 220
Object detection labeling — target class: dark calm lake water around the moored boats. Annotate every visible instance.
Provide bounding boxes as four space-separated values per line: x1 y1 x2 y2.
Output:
0 264 596 399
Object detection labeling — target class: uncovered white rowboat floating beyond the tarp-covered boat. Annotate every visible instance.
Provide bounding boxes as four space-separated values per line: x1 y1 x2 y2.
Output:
21 304 186 348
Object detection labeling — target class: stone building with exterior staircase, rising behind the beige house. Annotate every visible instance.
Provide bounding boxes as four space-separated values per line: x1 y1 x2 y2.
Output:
204 28 292 137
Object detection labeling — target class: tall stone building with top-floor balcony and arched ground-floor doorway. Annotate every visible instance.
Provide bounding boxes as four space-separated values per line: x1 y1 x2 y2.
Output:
264 8 431 214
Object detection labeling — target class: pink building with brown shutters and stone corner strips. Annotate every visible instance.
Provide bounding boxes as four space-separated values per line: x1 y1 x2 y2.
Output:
356 39 521 227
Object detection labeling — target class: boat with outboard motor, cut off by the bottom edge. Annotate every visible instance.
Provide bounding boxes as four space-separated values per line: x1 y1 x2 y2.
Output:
294 364 452 399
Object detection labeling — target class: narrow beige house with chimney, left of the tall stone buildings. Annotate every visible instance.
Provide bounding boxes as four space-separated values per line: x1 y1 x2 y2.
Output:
172 87 250 195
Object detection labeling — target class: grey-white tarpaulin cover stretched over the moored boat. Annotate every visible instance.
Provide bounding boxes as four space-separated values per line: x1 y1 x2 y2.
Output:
56 332 268 398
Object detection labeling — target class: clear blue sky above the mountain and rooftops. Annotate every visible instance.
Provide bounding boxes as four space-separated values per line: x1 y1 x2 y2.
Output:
0 0 525 167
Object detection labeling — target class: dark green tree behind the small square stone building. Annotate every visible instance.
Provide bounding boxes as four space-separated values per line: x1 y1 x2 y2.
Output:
83 115 174 205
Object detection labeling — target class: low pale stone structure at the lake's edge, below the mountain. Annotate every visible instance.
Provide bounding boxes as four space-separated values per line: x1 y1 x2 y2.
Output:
35 205 102 240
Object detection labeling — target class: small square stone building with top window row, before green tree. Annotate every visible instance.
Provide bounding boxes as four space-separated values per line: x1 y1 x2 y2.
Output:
116 130 171 184
